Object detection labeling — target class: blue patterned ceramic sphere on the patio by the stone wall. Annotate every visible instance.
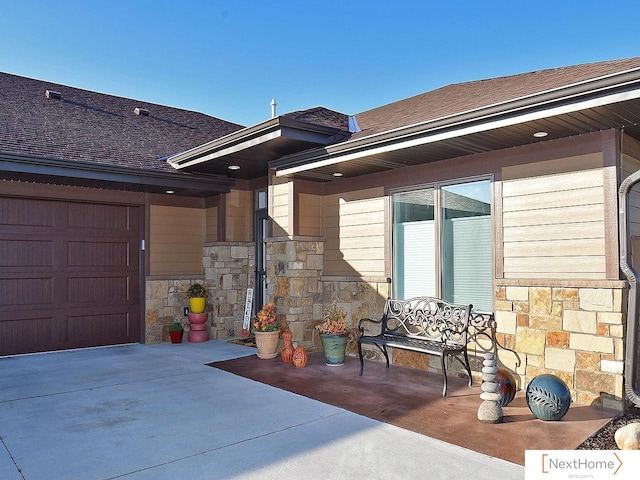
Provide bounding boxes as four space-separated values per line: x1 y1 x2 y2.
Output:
526 373 571 420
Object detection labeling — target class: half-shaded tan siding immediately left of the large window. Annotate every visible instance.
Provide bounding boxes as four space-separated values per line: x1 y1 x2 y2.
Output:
324 188 385 276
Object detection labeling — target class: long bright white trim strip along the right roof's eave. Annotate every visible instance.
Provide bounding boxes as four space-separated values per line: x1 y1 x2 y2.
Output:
276 89 640 177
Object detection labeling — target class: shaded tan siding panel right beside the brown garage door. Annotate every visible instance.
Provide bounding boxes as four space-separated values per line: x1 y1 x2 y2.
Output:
149 205 205 275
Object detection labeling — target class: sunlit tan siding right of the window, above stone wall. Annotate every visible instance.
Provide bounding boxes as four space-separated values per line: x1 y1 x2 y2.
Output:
502 154 606 279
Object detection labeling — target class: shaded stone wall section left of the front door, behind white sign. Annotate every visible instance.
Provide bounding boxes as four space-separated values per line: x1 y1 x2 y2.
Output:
203 242 255 340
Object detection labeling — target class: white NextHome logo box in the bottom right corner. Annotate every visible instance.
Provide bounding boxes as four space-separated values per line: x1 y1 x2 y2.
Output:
525 450 640 480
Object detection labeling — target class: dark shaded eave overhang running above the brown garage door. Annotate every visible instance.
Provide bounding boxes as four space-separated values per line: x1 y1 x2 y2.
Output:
0 152 234 197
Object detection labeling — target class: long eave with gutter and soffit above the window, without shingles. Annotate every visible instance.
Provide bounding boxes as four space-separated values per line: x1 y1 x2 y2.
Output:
270 69 640 180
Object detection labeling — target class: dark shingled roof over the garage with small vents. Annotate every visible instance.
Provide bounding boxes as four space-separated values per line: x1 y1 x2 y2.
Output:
0 73 243 173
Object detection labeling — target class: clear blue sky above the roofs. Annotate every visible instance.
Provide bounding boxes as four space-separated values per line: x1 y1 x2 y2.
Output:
0 0 640 126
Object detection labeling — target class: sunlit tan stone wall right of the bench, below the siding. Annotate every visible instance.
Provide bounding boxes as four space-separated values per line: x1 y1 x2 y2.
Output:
496 281 627 409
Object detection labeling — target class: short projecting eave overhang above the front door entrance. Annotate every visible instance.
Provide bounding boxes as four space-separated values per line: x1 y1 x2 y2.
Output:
167 116 346 180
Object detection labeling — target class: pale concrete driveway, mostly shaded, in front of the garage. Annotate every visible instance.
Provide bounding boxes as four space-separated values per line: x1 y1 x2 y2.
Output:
0 341 524 480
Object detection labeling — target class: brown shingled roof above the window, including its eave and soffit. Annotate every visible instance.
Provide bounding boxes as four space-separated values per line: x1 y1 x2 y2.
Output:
270 57 640 181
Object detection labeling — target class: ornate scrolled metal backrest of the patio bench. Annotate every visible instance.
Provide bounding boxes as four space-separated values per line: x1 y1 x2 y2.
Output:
382 297 472 346
